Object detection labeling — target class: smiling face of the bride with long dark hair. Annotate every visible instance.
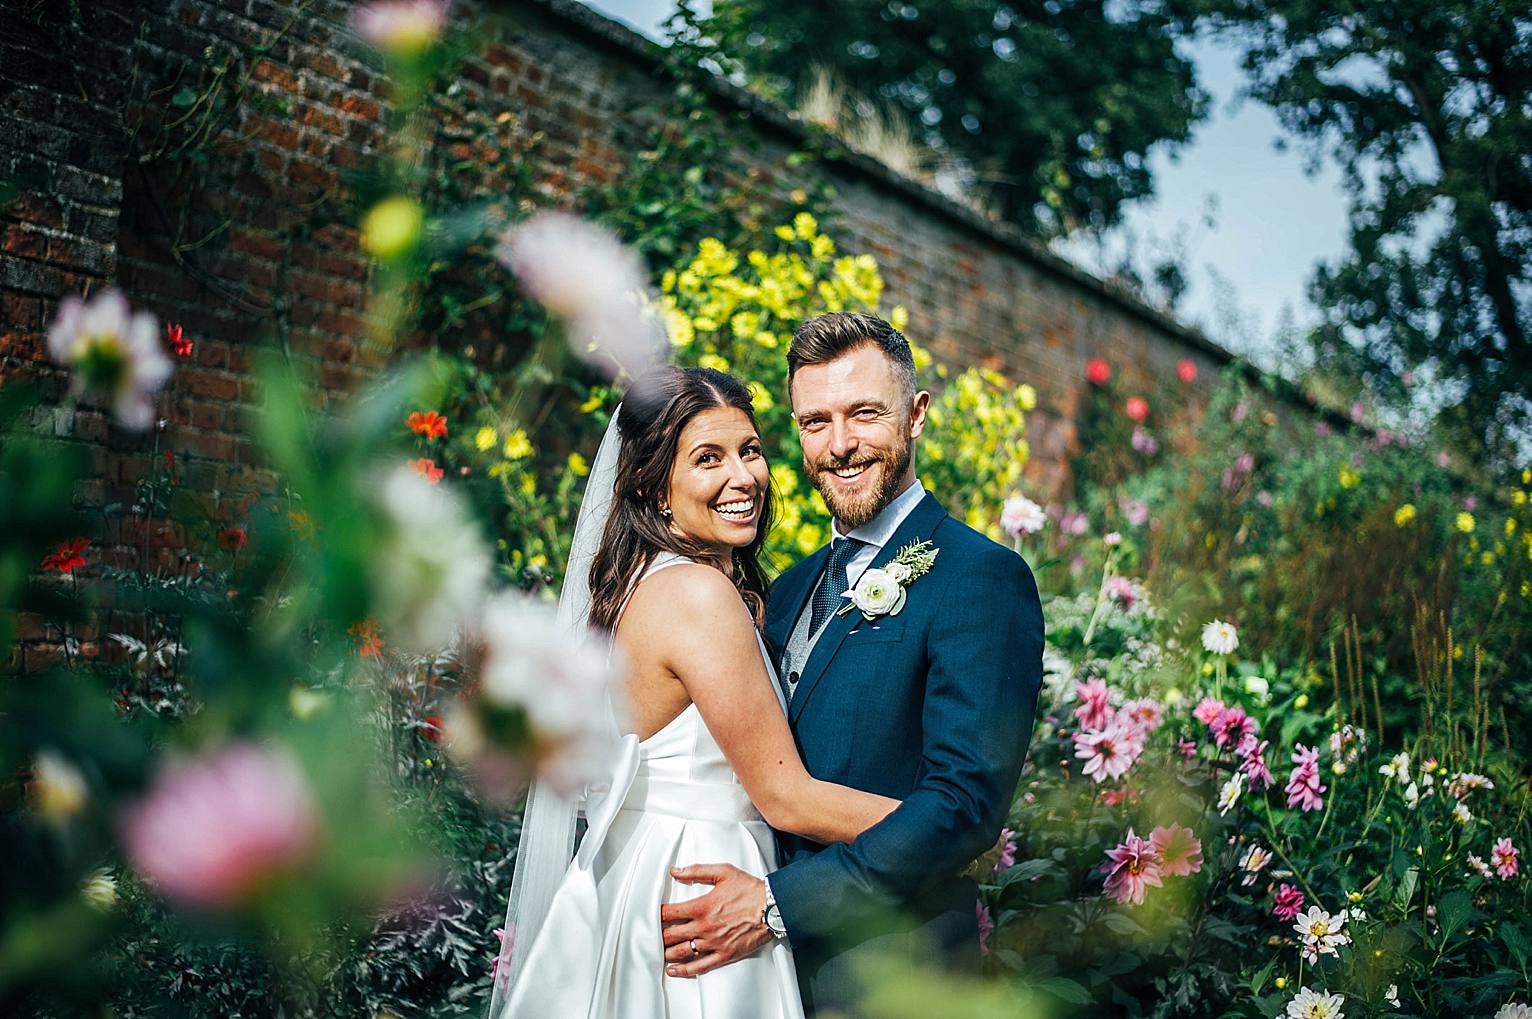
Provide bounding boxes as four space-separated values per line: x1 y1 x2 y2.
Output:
668 408 771 552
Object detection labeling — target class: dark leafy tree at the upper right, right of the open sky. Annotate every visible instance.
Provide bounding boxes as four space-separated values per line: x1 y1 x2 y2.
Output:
1170 0 1532 454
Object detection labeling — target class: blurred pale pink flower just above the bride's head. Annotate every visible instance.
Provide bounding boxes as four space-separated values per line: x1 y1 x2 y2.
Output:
499 211 663 377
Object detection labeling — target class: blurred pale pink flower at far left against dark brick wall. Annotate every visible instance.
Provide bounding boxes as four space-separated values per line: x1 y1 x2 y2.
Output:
47 290 172 431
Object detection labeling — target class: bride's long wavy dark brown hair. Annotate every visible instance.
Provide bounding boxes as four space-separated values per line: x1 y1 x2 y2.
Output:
590 366 774 630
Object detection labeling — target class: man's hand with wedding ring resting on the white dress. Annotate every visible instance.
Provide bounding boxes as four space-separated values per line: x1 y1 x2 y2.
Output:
660 863 772 976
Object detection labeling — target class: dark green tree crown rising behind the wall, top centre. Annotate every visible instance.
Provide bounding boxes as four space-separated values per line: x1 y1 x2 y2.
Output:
705 0 1207 234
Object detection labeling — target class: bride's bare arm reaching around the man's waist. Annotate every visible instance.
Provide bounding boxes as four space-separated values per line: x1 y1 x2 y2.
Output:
624 565 899 844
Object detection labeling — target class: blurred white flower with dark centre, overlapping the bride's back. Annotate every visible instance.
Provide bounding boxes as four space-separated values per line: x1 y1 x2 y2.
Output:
446 591 616 800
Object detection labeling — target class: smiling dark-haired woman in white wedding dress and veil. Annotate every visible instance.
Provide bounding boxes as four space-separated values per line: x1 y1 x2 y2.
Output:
490 368 898 1019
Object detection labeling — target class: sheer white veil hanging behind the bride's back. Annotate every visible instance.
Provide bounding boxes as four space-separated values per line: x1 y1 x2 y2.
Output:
489 406 622 1019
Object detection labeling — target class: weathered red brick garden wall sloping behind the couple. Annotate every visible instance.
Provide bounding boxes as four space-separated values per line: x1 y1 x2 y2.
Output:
0 0 1227 667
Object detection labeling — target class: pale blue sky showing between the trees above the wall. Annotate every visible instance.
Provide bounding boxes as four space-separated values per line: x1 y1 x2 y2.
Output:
584 0 1345 360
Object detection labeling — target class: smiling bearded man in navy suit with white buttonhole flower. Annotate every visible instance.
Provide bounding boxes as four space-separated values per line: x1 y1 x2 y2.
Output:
660 313 1043 1014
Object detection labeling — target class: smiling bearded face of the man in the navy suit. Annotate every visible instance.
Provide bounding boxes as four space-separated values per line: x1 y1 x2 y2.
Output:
792 343 930 530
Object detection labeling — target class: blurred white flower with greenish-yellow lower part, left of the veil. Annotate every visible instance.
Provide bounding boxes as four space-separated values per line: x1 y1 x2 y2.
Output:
372 466 490 654
